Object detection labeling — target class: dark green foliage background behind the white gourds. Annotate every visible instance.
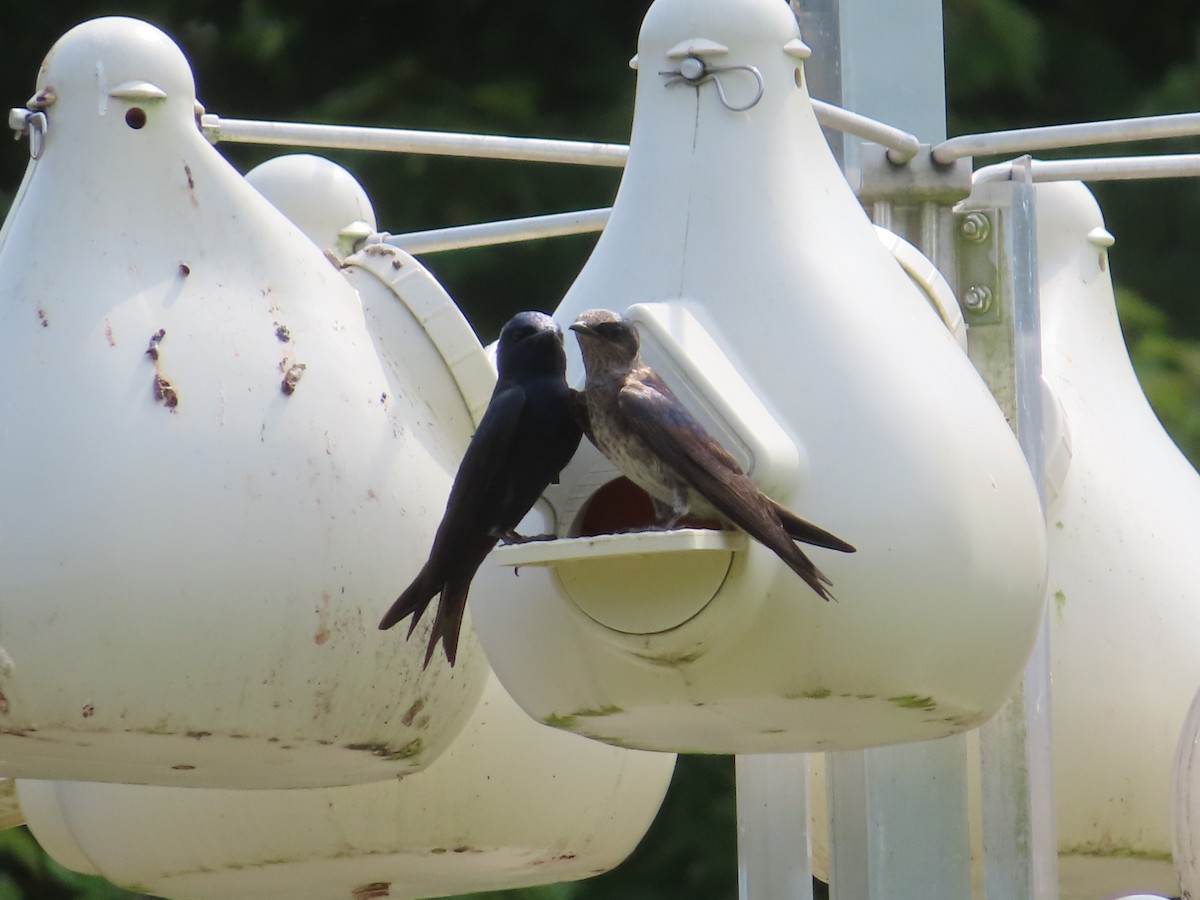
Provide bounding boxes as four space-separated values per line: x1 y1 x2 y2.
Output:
0 0 1200 900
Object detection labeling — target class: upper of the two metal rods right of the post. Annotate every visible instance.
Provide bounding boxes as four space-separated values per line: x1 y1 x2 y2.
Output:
932 113 1200 164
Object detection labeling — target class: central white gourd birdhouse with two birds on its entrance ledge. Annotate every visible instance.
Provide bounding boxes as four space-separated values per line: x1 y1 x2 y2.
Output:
463 0 1045 752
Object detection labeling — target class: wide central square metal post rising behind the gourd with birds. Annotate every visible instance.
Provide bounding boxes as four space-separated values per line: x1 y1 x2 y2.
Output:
793 0 971 900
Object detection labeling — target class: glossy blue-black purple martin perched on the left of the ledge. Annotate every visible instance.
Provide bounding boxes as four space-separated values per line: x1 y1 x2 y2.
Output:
379 312 582 667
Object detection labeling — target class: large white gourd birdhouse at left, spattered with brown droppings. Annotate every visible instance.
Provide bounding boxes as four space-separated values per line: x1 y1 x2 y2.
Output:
0 18 487 787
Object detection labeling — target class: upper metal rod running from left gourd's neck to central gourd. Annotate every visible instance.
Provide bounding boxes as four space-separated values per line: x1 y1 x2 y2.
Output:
200 115 629 168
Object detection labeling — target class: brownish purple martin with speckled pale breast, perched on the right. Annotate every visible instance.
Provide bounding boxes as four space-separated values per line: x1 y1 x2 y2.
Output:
571 310 854 600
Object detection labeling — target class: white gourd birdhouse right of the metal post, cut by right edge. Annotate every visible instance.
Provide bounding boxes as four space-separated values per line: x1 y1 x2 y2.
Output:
1037 182 1200 900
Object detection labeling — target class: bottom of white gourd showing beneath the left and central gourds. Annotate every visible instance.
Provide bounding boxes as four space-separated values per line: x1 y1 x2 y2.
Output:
18 678 674 900
